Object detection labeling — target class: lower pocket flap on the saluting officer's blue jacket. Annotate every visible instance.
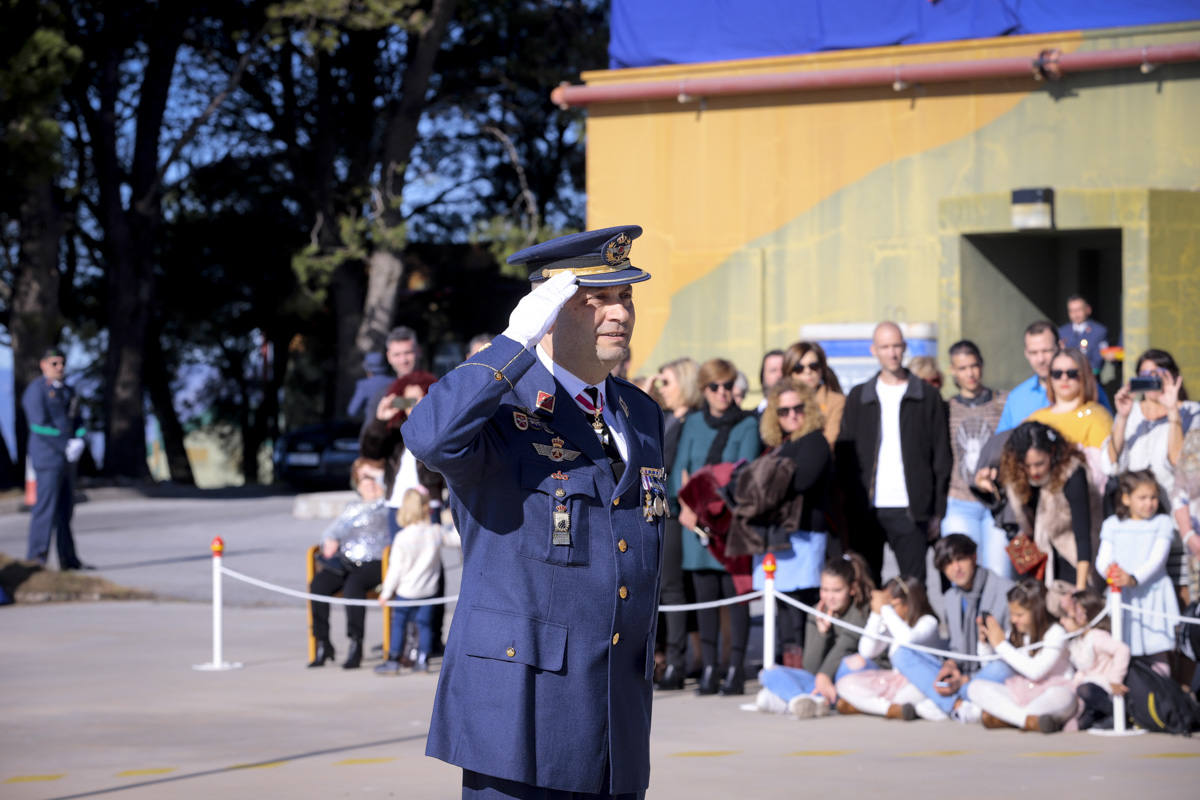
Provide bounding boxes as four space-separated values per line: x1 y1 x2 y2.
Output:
463 608 566 672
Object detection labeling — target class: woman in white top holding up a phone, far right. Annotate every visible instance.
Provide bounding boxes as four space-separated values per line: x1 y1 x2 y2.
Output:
1105 349 1200 604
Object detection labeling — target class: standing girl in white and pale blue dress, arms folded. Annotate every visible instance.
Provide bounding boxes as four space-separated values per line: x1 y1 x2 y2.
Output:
1096 470 1180 675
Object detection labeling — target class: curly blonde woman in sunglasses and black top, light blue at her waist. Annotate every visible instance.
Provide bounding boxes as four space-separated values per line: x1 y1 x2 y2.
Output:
754 377 833 668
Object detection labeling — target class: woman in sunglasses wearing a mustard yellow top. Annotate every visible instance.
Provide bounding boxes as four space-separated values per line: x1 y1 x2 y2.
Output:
1028 348 1112 449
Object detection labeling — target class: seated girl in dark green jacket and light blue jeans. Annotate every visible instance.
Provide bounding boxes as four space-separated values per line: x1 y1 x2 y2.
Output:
756 553 875 720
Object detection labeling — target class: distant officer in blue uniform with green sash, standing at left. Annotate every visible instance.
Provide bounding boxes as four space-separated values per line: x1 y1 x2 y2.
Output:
20 348 91 570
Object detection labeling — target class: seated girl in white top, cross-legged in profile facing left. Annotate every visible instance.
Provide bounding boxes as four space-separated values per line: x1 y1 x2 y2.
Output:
967 578 1075 733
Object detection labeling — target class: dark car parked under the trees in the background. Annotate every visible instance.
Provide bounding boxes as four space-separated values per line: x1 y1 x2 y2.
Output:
271 420 362 488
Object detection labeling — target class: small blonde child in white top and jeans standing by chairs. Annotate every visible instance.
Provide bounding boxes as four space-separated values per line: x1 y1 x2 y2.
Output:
376 488 462 675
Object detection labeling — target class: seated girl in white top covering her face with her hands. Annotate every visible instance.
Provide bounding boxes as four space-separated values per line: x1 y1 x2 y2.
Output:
838 577 946 720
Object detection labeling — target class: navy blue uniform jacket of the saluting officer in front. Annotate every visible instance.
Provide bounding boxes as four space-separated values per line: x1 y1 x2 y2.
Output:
403 336 665 794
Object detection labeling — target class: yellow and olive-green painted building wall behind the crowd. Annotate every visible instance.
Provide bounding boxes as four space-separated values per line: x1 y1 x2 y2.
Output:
584 24 1200 391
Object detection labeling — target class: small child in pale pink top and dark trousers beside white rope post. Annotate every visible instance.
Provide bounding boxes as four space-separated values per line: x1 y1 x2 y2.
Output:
1061 589 1129 730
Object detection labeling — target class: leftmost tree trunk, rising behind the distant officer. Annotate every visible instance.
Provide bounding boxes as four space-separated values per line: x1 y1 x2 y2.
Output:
8 176 62 483
